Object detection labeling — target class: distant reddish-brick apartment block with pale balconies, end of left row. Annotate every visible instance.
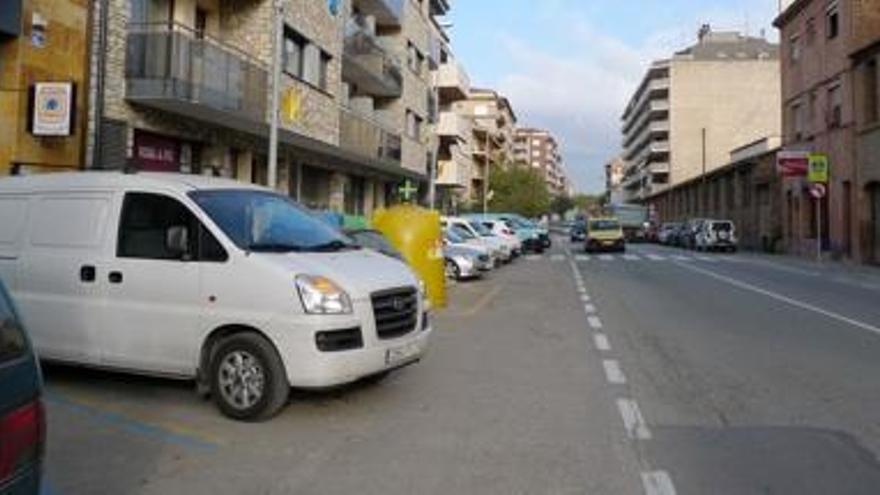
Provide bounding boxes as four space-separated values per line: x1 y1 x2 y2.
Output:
513 128 567 196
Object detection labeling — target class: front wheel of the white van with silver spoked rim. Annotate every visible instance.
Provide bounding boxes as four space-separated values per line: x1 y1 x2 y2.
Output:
211 333 290 421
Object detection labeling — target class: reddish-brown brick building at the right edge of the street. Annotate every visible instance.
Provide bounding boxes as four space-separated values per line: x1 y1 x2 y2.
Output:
775 0 880 261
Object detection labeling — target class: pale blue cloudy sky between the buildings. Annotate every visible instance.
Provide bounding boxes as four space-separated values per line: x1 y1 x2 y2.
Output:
447 0 778 193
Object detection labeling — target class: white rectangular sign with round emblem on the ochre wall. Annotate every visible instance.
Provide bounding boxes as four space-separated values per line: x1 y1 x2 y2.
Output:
31 82 74 136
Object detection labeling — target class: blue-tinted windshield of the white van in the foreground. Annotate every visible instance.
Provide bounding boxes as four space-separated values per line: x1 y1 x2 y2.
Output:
190 189 357 252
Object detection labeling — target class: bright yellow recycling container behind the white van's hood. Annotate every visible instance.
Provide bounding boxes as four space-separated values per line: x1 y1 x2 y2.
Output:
372 205 446 308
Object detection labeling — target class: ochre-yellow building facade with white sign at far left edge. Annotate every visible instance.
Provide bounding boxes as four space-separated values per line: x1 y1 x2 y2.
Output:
0 0 89 175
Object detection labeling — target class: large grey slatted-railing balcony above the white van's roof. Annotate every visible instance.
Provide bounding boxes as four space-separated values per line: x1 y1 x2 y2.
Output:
125 23 269 126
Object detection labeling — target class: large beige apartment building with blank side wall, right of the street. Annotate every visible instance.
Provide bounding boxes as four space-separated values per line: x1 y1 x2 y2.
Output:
621 25 780 201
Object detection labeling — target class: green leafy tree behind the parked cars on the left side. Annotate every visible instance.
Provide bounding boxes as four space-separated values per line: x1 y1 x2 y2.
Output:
489 166 550 218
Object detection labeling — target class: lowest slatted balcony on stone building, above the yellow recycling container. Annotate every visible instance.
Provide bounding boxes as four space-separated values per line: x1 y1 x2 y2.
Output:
339 108 401 165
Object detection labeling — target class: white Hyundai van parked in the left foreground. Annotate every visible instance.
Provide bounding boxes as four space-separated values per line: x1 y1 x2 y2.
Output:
0 172 431 420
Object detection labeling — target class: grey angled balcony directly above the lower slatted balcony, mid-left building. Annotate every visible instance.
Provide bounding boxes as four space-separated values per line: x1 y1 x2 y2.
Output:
342 16 403 98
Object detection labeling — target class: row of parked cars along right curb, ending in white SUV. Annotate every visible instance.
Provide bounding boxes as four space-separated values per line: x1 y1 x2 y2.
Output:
657 218 739 252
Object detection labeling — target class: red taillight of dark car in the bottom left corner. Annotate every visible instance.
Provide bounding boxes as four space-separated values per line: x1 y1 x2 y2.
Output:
0 399 46 484
